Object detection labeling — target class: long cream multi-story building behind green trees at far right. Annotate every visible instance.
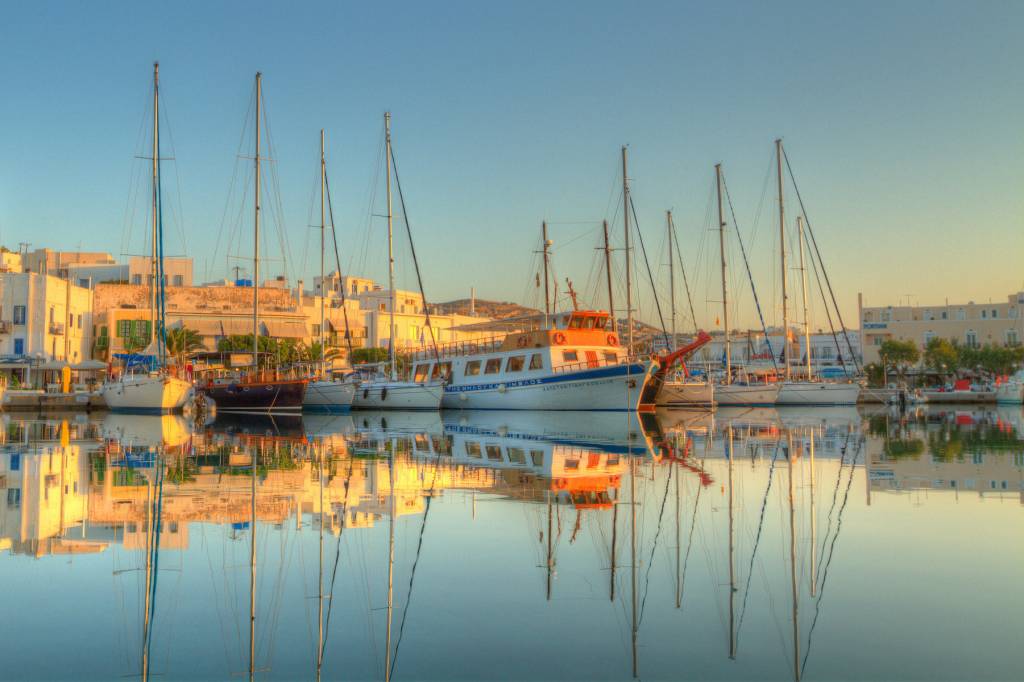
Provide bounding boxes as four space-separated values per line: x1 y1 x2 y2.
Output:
858 292 1024 363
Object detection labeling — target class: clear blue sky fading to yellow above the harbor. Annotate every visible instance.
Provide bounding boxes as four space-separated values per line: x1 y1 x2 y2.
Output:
0 1 1024 329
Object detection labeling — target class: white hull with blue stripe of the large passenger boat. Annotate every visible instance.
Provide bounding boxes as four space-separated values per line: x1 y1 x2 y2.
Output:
442 364 653 412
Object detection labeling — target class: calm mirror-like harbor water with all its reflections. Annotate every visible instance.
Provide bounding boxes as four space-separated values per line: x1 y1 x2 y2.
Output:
0 408 1024 680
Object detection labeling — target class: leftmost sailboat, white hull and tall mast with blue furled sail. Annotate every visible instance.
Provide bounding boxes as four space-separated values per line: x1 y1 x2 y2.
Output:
99 61 193 414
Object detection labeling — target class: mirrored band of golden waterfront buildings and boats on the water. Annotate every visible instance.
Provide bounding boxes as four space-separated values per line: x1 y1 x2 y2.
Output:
0 409 1024 557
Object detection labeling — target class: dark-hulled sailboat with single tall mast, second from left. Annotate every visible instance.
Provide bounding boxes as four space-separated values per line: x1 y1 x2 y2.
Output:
201 73 307 415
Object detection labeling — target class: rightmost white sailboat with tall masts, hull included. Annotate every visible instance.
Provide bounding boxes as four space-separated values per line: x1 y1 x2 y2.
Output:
775 139 860 406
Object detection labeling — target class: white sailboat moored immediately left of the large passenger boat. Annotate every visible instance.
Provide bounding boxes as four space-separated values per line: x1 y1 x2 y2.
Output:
352 112 451 410
